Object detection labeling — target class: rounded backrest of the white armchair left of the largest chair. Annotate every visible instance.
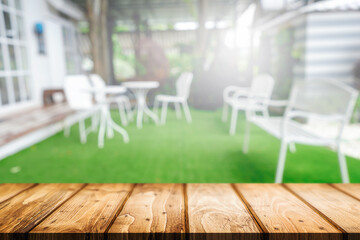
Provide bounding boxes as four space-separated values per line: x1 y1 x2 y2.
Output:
250 74 275 100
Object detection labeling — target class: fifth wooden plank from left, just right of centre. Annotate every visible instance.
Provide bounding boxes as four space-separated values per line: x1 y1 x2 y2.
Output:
187 184 260 239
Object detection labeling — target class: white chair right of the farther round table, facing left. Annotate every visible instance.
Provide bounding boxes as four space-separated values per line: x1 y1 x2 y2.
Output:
154 72 193 124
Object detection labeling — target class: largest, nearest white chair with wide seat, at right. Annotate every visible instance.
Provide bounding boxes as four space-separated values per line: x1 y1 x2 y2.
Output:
249 80 358 183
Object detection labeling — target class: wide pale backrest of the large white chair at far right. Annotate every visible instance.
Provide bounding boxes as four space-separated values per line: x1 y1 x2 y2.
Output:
287 79 358 123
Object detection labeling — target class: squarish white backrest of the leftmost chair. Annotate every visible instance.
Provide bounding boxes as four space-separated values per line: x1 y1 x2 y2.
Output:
64 75 94 110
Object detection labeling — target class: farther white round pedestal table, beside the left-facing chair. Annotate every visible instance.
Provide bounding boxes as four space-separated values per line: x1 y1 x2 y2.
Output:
122 81 159 128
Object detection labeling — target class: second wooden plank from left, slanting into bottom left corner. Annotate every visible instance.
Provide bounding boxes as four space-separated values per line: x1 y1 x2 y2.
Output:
0 184 83 238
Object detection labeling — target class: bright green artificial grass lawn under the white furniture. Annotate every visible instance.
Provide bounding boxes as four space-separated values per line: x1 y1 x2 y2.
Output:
0 110 360 183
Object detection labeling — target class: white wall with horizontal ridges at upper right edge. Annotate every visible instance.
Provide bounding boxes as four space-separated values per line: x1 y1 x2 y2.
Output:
305 12 360 82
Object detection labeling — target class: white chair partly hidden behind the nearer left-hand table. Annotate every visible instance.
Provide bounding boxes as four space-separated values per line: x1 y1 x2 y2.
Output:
90 74 133 126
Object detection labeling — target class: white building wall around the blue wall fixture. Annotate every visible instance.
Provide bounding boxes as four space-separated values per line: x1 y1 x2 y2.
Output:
24 0 75 105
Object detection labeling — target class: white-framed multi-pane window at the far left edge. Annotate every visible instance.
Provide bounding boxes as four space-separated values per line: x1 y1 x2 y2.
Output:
0 0 31 107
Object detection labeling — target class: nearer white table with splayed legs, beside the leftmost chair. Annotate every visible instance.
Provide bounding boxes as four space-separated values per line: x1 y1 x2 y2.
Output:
84 86 129 148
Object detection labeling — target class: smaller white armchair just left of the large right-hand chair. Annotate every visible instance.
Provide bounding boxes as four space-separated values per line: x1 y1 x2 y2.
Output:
223 74 274 135
